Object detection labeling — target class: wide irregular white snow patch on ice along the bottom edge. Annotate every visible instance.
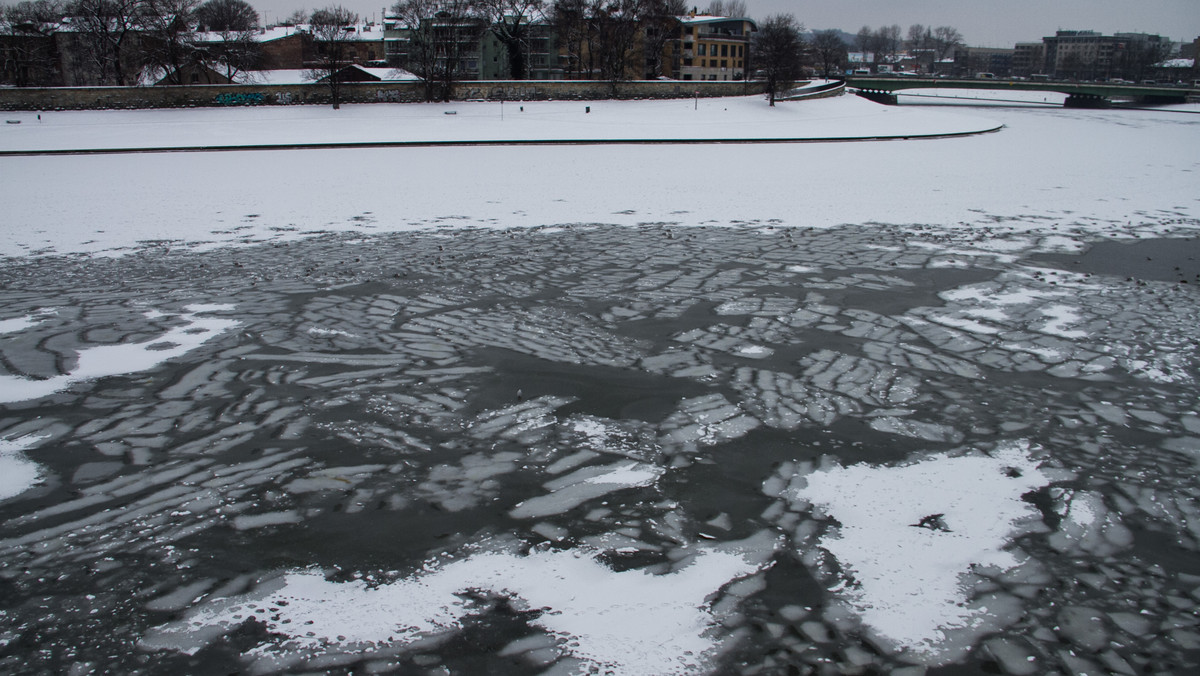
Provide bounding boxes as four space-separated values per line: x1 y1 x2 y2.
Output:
143 532 775 675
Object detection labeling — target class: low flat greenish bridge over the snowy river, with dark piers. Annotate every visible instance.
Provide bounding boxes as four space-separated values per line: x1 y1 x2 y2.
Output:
846 76 1200 108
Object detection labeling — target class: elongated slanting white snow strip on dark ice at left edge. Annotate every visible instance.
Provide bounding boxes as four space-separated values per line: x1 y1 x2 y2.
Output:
0 304 238 403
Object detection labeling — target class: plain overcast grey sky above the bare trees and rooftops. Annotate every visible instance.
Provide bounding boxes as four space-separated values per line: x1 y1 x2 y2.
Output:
250 0 1200 47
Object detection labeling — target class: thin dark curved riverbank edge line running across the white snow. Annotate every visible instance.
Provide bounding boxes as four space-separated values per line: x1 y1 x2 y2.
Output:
0 125 1004 157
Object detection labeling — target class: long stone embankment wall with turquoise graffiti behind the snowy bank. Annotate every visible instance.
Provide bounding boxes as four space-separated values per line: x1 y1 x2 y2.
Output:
0 80 766 110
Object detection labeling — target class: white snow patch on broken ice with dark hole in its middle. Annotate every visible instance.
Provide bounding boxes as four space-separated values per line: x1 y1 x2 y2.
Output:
792 442 1052 664
